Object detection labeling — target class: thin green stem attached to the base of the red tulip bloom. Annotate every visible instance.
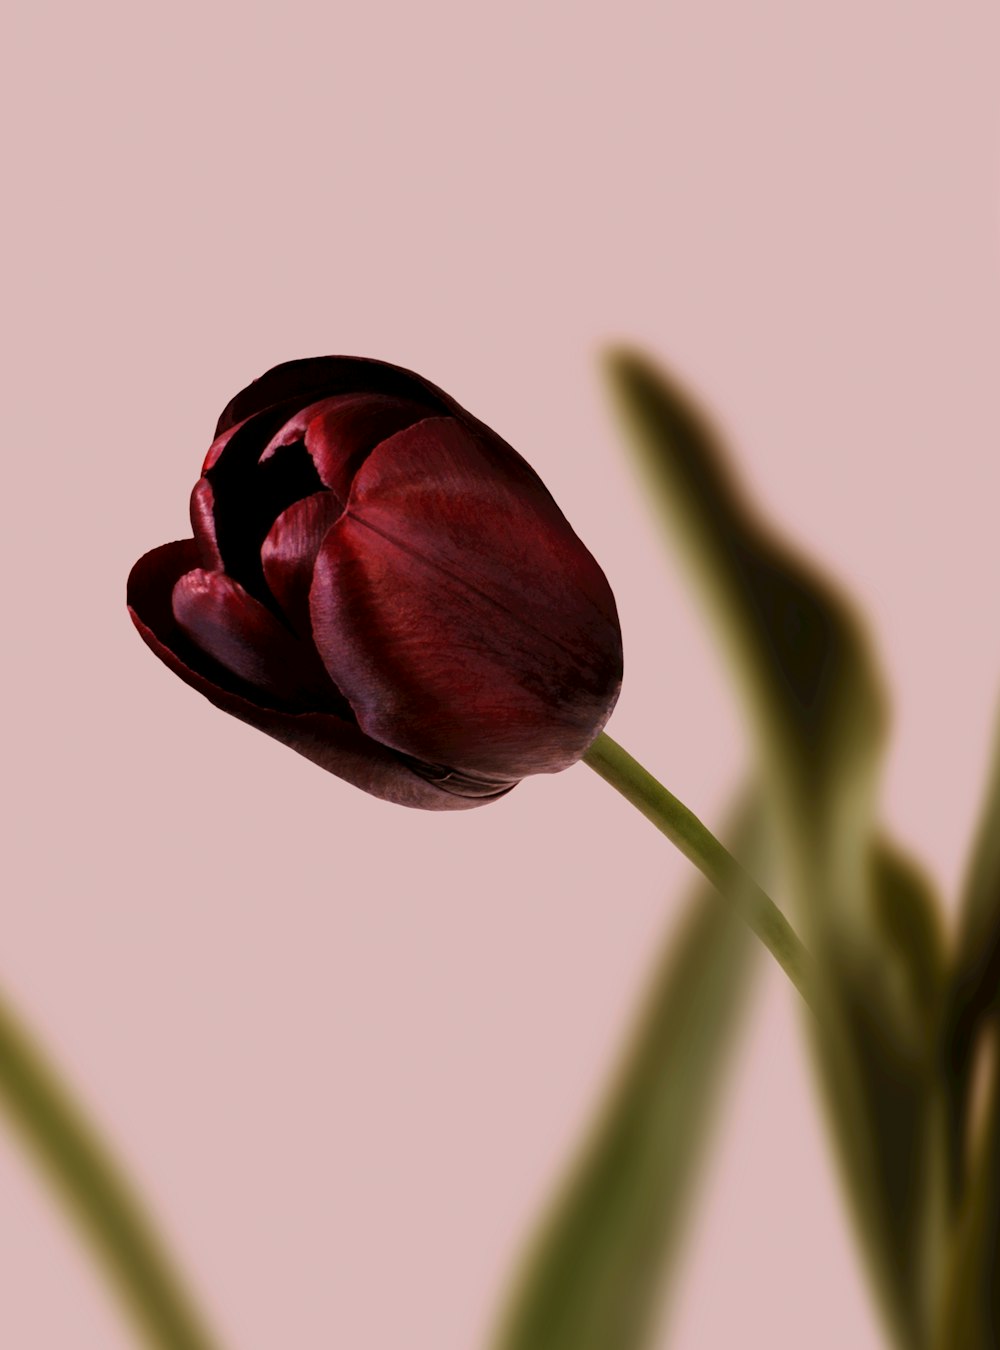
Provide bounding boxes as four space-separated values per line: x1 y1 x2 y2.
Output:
583 733 814 1004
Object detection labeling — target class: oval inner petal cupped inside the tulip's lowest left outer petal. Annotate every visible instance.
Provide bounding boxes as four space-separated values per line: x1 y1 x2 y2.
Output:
173 567 336 707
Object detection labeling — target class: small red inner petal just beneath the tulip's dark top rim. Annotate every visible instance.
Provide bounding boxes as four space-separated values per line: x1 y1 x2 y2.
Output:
260 394 430 505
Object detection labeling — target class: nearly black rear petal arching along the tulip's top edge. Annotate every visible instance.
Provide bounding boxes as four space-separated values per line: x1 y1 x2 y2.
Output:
216 356 453 436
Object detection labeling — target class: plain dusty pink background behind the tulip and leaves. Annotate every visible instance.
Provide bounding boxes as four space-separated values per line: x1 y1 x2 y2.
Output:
0 0 1000 1350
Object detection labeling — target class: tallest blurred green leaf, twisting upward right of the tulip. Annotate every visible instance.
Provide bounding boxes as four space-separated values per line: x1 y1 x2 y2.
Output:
609 351 941 1347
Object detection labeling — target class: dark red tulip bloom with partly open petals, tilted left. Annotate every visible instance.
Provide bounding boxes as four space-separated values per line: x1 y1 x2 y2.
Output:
128 356 622 810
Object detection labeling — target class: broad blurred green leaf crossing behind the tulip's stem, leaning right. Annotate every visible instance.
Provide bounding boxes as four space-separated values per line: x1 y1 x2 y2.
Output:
494 807 761 1350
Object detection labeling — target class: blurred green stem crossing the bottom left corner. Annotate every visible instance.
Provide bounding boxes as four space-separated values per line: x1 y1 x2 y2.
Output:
0 999 224 1350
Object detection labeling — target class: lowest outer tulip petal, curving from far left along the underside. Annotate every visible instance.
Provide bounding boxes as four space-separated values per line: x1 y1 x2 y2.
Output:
128 539 499 811
